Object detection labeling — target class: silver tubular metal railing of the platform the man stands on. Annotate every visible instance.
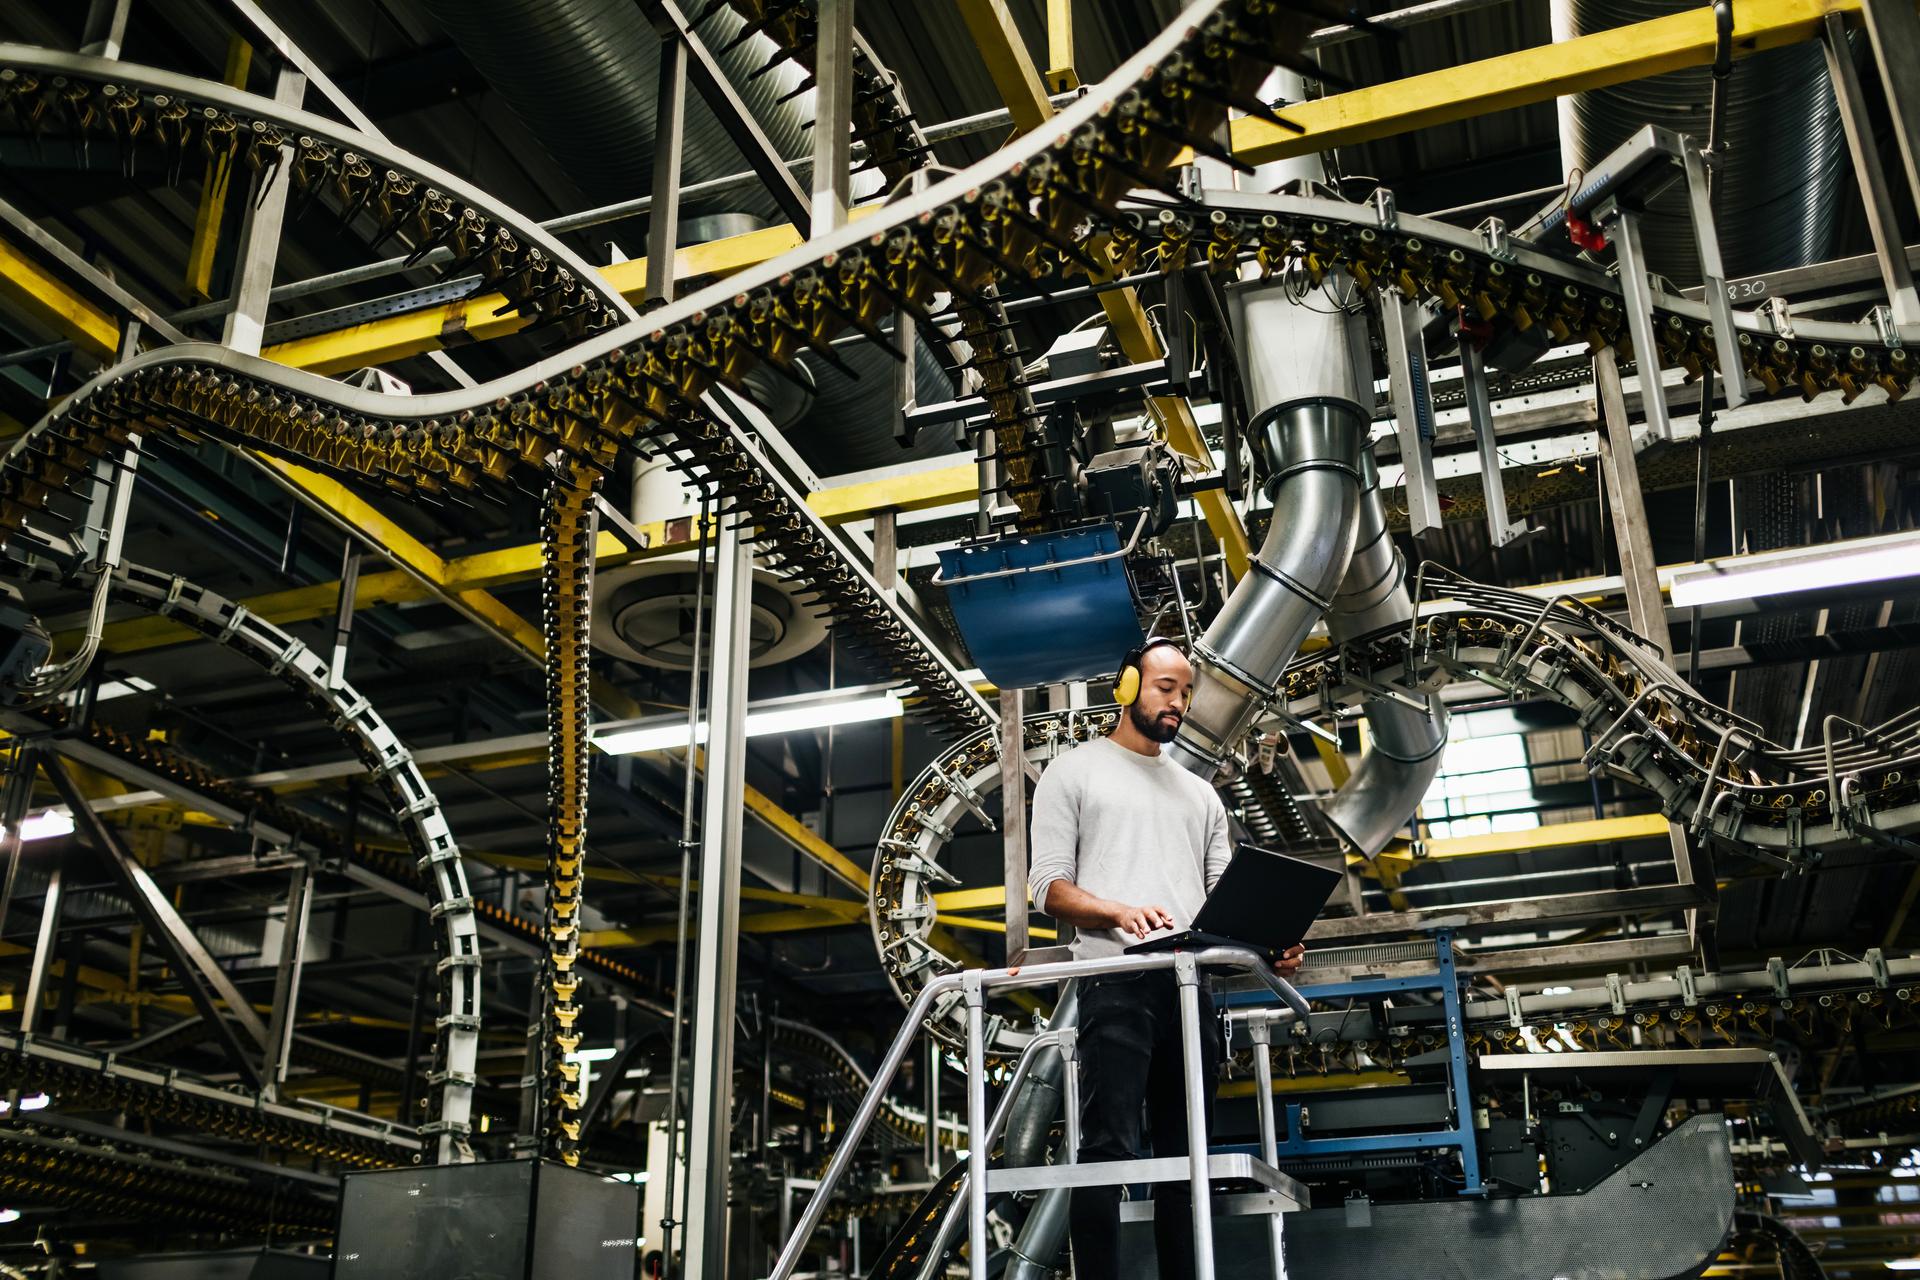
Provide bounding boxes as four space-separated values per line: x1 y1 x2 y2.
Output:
768 946 1308 1280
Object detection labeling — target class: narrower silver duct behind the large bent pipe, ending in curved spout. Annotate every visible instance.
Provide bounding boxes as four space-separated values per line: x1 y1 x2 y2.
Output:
1323 453 1446 858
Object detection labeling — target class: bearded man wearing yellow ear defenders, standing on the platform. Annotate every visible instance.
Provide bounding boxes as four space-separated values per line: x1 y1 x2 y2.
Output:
1027 637 1304 1280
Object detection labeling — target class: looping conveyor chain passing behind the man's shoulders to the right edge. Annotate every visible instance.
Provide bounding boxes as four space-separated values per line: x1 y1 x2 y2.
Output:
868 587 1920 1052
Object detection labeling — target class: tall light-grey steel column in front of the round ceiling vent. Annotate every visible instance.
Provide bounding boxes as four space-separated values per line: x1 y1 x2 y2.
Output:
685 512 753 1280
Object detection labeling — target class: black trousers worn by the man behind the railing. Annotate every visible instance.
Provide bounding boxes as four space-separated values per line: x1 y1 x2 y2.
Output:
1068 969 1221 1280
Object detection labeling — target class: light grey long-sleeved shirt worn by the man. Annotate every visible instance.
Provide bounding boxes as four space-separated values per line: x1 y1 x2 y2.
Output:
1027 737 1233 960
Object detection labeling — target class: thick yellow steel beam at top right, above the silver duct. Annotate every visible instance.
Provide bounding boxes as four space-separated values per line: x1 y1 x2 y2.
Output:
1231 0 1860 165
